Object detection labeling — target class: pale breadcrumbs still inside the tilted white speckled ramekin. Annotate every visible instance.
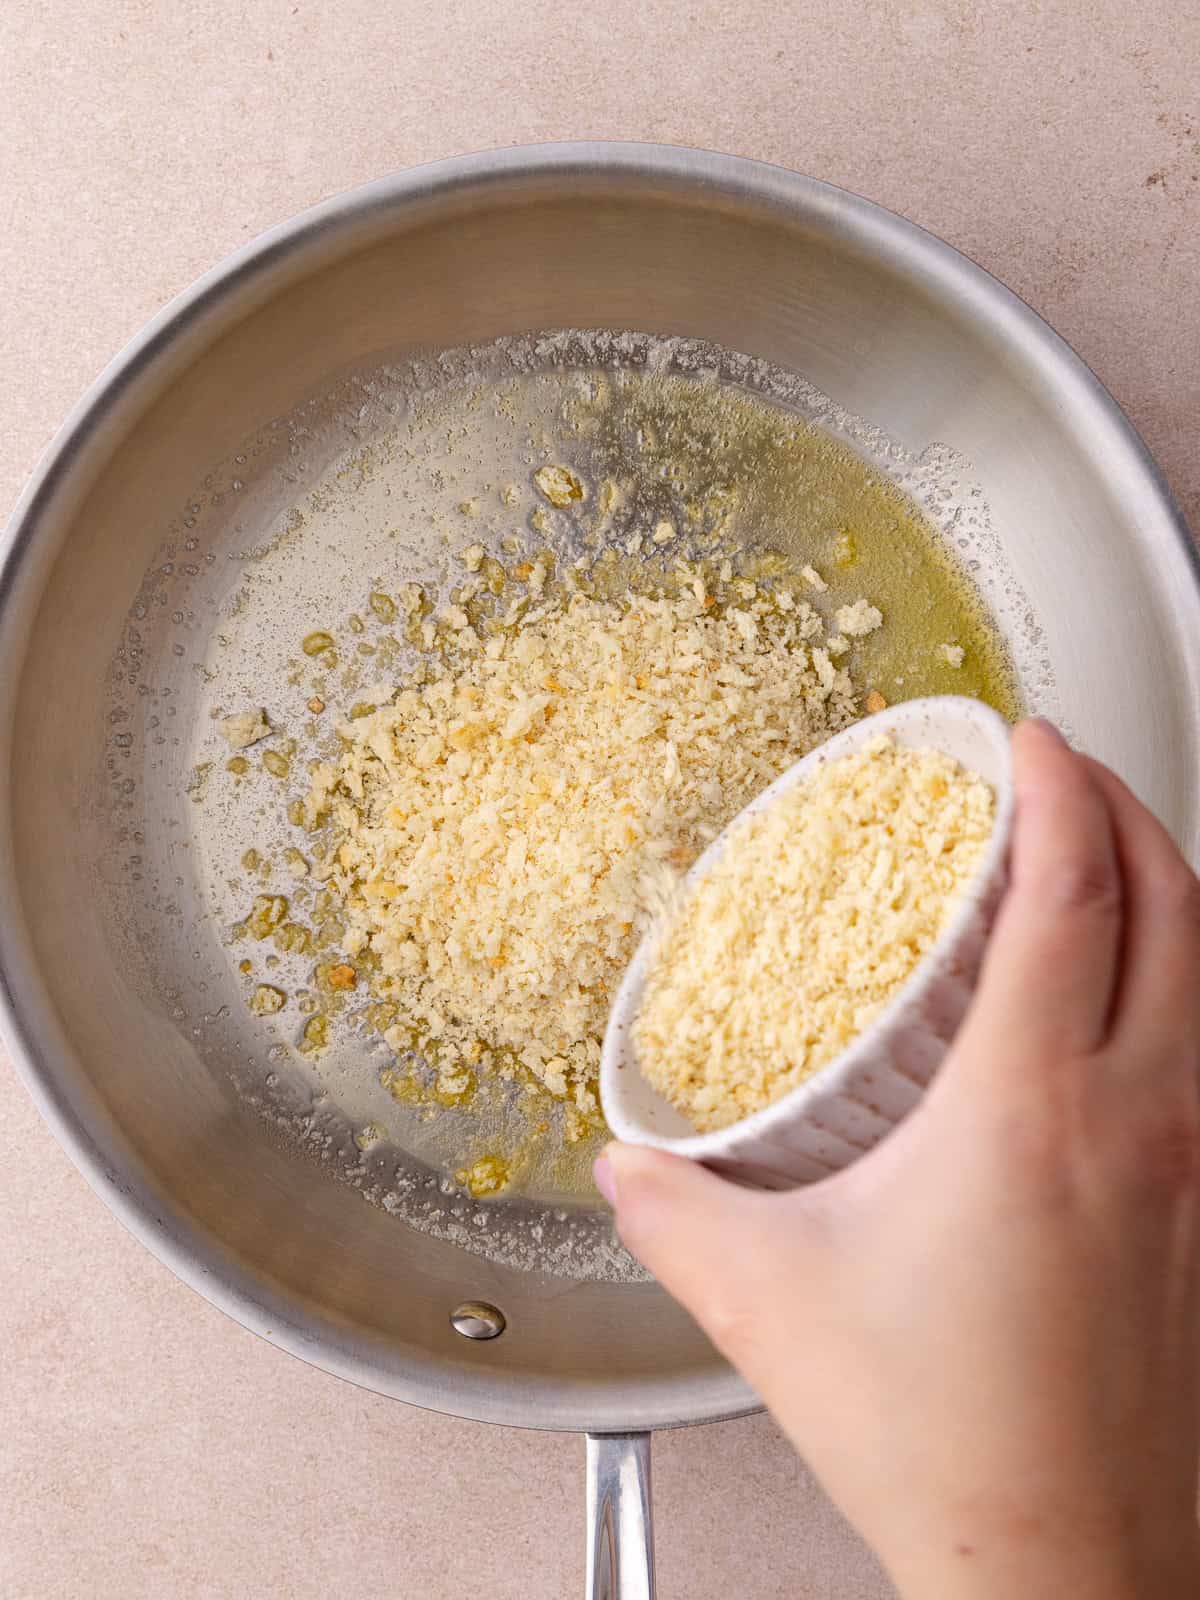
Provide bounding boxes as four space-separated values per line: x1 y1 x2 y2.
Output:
634 738 995 1131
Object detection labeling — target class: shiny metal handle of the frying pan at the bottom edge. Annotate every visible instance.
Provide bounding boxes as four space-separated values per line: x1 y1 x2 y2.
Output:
587 1434 654 1600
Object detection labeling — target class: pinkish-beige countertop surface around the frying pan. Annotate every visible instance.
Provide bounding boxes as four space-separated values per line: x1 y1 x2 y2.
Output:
0 0 1200 1600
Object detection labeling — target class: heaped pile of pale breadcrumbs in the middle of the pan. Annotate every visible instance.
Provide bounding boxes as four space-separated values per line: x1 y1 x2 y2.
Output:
304 549 882 1136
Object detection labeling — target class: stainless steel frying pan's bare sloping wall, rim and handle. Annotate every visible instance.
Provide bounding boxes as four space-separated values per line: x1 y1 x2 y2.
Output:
0 144 1200 1597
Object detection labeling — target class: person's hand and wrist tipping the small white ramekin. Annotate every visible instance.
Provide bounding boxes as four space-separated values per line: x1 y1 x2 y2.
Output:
597 723 1200 1600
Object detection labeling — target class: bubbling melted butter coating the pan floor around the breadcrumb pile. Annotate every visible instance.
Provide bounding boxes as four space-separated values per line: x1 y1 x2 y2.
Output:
104 331 1054 1282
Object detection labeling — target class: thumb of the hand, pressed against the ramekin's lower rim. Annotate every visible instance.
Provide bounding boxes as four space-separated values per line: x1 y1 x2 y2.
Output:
595 1144 803 1365
